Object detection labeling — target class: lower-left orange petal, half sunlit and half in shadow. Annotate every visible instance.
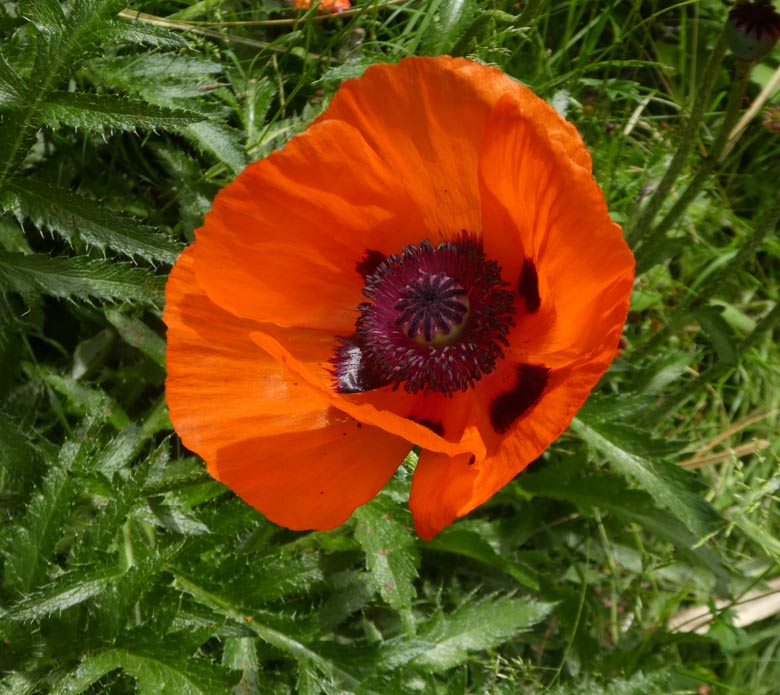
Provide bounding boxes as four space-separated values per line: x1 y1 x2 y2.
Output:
163 247 410 530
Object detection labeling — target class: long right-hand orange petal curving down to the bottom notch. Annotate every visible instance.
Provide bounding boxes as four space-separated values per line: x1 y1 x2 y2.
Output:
410 91 634 538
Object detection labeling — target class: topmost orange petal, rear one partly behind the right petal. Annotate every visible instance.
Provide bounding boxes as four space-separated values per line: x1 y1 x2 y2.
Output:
319 56 590 235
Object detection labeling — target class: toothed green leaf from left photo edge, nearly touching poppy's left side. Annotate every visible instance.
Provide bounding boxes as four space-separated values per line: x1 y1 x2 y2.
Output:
0 252 165 305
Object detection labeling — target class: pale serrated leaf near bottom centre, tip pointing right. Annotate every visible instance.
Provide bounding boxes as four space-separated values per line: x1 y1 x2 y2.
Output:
413 596 554 673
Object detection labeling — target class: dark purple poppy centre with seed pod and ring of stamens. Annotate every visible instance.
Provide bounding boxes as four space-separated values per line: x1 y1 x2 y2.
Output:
332 232 514 396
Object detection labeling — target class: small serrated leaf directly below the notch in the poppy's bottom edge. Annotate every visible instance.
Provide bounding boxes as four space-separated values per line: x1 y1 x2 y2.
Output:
354 496 420 610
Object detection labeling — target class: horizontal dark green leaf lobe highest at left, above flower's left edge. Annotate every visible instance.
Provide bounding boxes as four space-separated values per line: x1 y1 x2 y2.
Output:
40 92 203 132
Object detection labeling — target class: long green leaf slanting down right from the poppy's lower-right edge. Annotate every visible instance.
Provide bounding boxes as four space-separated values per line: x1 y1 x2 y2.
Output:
571 418 720 538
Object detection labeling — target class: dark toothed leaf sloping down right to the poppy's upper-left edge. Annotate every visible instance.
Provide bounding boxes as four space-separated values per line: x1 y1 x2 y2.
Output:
8 178 181 263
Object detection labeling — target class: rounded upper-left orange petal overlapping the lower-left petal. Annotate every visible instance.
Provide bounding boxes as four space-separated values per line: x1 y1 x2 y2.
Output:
195 121 423 333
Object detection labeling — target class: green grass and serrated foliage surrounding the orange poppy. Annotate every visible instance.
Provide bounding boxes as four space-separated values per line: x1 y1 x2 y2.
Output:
0 0 780 695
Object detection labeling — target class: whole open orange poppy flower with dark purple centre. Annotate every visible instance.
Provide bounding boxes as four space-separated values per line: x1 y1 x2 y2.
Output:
164 57 634 539
